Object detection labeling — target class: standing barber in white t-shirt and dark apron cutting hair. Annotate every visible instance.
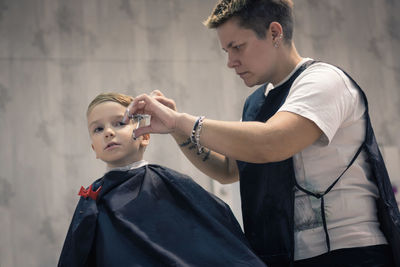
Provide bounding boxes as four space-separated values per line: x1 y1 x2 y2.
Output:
123 0 400 266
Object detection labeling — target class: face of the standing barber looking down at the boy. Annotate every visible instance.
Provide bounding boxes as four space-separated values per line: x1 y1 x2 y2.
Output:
217 18 276 87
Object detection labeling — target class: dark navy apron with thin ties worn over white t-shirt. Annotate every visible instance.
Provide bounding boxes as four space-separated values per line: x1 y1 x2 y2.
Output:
237 61 400 266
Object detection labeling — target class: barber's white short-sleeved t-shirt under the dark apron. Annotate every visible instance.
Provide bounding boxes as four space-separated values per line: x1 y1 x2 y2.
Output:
266 58 387 260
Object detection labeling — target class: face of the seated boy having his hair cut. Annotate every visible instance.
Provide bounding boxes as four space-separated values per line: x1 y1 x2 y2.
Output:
87 101 149 168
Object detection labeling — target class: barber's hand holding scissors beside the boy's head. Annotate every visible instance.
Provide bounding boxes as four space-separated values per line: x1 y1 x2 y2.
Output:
124 91 179 137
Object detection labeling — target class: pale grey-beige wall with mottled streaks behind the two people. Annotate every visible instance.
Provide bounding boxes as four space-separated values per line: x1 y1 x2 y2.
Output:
0 0 400 267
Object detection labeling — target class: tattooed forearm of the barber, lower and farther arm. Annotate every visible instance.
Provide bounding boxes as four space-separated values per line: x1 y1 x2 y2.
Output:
171 132 239 184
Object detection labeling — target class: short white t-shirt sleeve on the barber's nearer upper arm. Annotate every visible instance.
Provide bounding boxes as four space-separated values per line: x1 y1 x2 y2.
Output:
278 63 354 145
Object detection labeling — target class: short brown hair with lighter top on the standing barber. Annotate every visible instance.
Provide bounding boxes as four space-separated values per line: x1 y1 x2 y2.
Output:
203 0 293 42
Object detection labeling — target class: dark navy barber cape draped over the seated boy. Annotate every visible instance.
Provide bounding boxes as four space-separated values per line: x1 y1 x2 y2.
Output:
58 165 265 267
